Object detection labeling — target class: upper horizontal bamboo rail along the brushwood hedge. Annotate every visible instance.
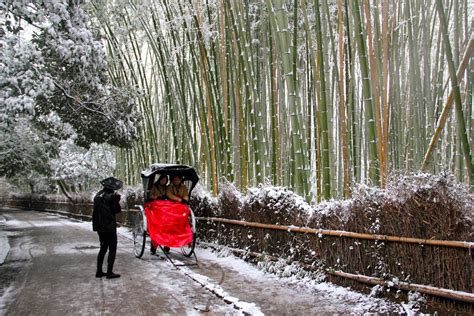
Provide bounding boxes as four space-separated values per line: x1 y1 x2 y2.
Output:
197 217 474 249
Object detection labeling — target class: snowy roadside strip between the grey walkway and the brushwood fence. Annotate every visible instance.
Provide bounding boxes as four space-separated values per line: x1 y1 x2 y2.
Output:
115 228 412 315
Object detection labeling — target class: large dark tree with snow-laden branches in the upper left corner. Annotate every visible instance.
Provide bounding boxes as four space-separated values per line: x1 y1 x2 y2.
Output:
0 0 139 147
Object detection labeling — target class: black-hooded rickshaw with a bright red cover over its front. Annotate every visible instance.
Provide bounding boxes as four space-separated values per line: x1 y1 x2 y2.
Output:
132 163 199 264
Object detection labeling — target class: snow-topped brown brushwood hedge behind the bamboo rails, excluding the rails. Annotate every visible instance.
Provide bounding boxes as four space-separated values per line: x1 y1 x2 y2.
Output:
194 174 474 292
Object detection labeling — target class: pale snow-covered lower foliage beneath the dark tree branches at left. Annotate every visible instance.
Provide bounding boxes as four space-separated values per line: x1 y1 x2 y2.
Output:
0 117 115 192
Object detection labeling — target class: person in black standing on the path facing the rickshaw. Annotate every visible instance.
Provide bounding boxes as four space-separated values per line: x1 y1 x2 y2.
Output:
92 177 122 279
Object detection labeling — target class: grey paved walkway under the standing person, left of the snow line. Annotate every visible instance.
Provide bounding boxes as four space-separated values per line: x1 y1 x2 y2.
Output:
0 211 235 315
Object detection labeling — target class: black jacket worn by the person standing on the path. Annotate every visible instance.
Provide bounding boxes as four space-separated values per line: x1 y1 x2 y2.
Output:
92 189 121 232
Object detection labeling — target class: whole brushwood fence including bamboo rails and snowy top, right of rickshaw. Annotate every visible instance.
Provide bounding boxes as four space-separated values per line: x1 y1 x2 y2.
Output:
194 175 474 304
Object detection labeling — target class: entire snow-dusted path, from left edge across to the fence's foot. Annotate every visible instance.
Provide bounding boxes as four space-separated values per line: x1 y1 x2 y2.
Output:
0 210 401 315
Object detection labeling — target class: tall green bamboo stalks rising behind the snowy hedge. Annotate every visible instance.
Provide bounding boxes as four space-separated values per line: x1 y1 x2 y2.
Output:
0 0 474 201
